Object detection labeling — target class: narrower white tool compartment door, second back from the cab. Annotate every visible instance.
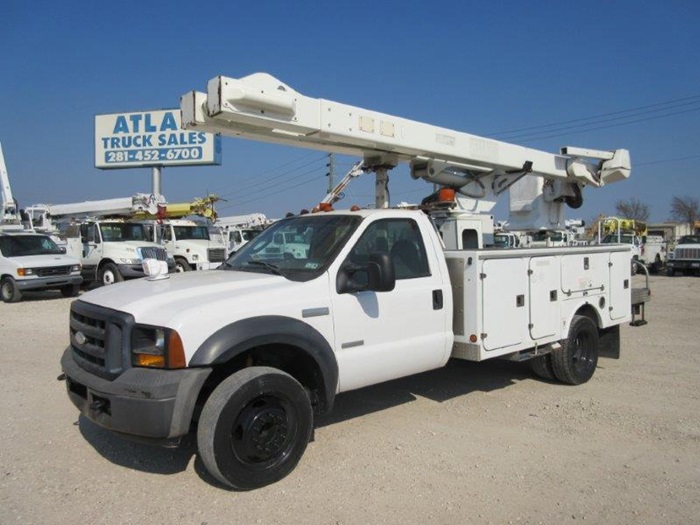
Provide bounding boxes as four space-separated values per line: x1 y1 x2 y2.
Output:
529 256 561 339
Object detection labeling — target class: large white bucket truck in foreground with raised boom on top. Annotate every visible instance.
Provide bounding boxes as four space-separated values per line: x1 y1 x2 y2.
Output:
61 74 644 489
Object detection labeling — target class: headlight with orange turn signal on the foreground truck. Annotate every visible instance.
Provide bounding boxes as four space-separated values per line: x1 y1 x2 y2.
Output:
131 325 186 368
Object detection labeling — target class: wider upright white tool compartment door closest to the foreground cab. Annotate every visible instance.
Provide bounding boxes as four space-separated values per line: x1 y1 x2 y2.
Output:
481 258 528 350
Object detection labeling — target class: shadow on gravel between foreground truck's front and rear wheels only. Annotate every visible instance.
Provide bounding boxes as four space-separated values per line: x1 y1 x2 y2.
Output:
315 359 533 428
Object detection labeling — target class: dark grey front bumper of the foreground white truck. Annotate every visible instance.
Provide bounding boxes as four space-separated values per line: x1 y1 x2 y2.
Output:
61 347 211 440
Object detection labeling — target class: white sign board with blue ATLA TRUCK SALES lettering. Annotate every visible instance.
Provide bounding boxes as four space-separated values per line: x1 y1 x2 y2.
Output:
95 109 221 169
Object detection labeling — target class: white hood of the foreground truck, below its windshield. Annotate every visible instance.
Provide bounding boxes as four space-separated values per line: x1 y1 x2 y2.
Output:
80 270 300 326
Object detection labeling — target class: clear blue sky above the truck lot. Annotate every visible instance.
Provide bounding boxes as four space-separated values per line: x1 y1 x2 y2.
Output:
0 0 700 221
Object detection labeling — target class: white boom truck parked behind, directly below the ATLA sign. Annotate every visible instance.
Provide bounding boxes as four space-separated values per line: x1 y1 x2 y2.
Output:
25 193 175 285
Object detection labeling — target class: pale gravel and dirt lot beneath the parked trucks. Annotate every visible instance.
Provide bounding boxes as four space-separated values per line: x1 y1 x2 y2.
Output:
0 276 700 525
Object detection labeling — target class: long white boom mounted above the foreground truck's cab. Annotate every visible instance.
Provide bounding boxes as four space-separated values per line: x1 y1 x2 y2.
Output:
180 73 630 212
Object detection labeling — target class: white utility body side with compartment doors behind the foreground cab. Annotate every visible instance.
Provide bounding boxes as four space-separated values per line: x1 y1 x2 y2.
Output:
445 246 631 361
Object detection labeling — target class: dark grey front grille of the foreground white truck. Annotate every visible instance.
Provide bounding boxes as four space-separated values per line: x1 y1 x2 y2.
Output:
70 301 134 379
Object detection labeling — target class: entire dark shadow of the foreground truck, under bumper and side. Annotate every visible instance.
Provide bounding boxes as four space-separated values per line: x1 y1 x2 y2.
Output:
77 360 532 491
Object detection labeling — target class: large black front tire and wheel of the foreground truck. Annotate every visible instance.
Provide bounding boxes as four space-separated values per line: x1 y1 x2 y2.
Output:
197 367 313 490
